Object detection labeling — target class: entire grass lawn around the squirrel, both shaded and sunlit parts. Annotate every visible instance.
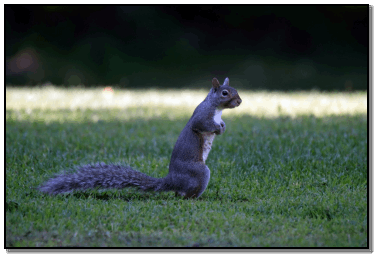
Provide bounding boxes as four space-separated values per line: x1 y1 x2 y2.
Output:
6 88 367 246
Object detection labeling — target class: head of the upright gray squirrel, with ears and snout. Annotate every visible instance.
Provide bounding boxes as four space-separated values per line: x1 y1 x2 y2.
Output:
210 78 242 109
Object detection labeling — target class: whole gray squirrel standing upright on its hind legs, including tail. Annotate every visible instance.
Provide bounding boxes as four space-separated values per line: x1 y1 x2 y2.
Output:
38 78 242 198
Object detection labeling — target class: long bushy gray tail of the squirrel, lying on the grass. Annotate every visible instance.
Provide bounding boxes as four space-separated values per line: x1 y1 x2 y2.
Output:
38 163 167 194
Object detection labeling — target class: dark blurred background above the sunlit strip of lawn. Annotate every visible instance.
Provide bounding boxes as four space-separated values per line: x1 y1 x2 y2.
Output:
6 6 367 91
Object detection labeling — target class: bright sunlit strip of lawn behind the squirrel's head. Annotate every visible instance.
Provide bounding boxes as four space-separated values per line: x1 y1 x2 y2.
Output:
6 87 367 118
